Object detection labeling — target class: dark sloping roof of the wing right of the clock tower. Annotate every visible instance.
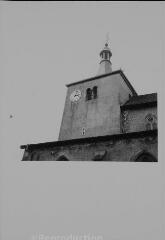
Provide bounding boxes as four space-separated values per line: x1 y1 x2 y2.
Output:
121 93 157 109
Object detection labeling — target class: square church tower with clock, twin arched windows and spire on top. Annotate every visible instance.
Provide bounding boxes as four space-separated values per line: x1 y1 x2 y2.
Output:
59 43 136 141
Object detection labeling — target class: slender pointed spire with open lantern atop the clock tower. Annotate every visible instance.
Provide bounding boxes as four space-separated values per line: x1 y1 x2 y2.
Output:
98 39 112 75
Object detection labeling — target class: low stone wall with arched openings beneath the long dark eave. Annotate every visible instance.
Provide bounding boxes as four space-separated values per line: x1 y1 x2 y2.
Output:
23 135 157 161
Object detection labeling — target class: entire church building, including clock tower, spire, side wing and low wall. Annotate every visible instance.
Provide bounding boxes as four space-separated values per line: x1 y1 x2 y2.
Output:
21 40 158 162
